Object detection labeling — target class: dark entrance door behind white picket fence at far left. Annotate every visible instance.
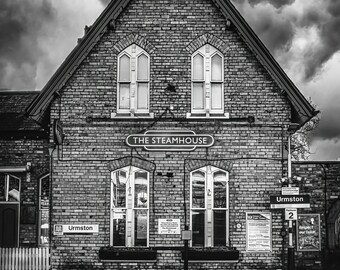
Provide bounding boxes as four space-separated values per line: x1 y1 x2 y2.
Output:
0 203 19 247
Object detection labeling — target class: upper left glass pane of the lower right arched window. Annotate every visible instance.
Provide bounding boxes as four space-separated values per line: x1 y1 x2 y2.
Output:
192 171 205 208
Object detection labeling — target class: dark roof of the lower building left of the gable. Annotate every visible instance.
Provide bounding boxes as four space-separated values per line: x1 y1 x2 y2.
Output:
0 91 47 138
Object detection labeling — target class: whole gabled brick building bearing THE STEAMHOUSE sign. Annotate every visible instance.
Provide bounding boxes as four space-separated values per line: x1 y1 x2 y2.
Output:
0 0 340 269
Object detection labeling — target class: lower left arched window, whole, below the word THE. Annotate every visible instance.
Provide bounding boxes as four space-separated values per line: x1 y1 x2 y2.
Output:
110 166 149 247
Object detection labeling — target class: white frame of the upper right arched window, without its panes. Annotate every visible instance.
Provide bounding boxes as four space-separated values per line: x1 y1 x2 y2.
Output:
191 44 224 117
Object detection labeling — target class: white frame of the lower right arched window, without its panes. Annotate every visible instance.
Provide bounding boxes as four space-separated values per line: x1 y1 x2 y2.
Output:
190 165 229 247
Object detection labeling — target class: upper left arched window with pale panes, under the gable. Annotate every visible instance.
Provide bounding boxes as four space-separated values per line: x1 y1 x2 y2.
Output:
117 44 150 115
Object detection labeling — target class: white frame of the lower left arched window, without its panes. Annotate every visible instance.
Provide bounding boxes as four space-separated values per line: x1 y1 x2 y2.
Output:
110 166 150 247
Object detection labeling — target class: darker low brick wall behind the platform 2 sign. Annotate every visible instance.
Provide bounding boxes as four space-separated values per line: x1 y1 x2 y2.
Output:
292 161 340 269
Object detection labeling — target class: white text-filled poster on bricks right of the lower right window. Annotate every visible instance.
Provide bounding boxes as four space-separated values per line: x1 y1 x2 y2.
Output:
246 212 272 252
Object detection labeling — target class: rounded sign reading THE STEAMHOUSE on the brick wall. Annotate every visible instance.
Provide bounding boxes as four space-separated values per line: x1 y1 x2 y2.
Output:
126 130 214 151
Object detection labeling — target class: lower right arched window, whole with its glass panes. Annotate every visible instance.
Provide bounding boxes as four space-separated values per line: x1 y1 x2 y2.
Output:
190 166 229 247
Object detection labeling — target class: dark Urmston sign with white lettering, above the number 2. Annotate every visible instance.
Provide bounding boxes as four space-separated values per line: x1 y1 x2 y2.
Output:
270 195 310 209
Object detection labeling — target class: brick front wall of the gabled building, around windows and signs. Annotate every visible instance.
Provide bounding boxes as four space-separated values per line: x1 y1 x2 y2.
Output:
51 0 290 269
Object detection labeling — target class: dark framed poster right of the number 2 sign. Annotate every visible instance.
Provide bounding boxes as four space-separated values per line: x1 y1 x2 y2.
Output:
296 214 321 251
